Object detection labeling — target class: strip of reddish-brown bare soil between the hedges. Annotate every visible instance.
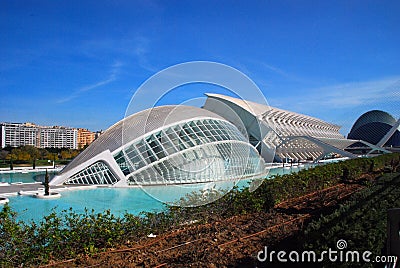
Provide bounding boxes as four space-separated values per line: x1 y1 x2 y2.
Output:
45 184 363 267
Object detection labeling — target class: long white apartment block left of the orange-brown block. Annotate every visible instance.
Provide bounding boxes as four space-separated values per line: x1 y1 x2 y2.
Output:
0 123 78 149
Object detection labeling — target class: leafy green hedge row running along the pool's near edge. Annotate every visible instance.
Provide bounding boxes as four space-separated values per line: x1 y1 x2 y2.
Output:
0 154 400 267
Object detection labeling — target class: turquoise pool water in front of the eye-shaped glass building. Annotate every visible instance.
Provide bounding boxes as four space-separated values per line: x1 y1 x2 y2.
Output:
1 167 306 222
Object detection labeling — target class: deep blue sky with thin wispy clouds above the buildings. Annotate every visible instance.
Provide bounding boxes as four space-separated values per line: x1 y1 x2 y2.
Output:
0 0 400 134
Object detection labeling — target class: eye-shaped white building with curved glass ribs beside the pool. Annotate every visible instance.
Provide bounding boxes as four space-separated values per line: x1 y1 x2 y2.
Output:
50 106 264 187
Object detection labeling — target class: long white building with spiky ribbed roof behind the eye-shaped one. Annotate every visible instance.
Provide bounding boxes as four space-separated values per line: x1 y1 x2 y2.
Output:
204 94 387 162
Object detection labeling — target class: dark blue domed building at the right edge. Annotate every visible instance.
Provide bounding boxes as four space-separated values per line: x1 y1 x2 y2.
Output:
347 110 400 147
